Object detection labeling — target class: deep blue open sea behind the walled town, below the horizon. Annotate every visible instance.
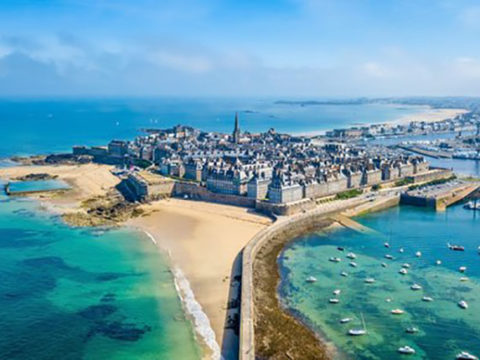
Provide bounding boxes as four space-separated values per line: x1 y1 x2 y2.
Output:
0 98 425 158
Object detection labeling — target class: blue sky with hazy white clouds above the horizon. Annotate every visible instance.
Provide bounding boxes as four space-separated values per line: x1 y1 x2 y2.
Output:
0 0 480 97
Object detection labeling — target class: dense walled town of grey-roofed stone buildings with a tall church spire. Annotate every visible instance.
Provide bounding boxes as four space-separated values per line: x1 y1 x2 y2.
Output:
73 115 450 213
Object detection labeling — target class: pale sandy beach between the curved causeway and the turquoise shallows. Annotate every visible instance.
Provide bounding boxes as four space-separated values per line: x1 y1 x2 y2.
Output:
128 199 271 359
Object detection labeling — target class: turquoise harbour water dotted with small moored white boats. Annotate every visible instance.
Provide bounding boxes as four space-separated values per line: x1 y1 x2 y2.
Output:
278 205 480 360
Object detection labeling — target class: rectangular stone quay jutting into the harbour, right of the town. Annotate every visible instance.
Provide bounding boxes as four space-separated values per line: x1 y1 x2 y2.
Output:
400 181 480 211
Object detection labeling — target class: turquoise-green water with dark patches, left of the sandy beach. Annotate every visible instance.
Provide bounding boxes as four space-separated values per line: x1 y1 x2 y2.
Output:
0 191 202 360
